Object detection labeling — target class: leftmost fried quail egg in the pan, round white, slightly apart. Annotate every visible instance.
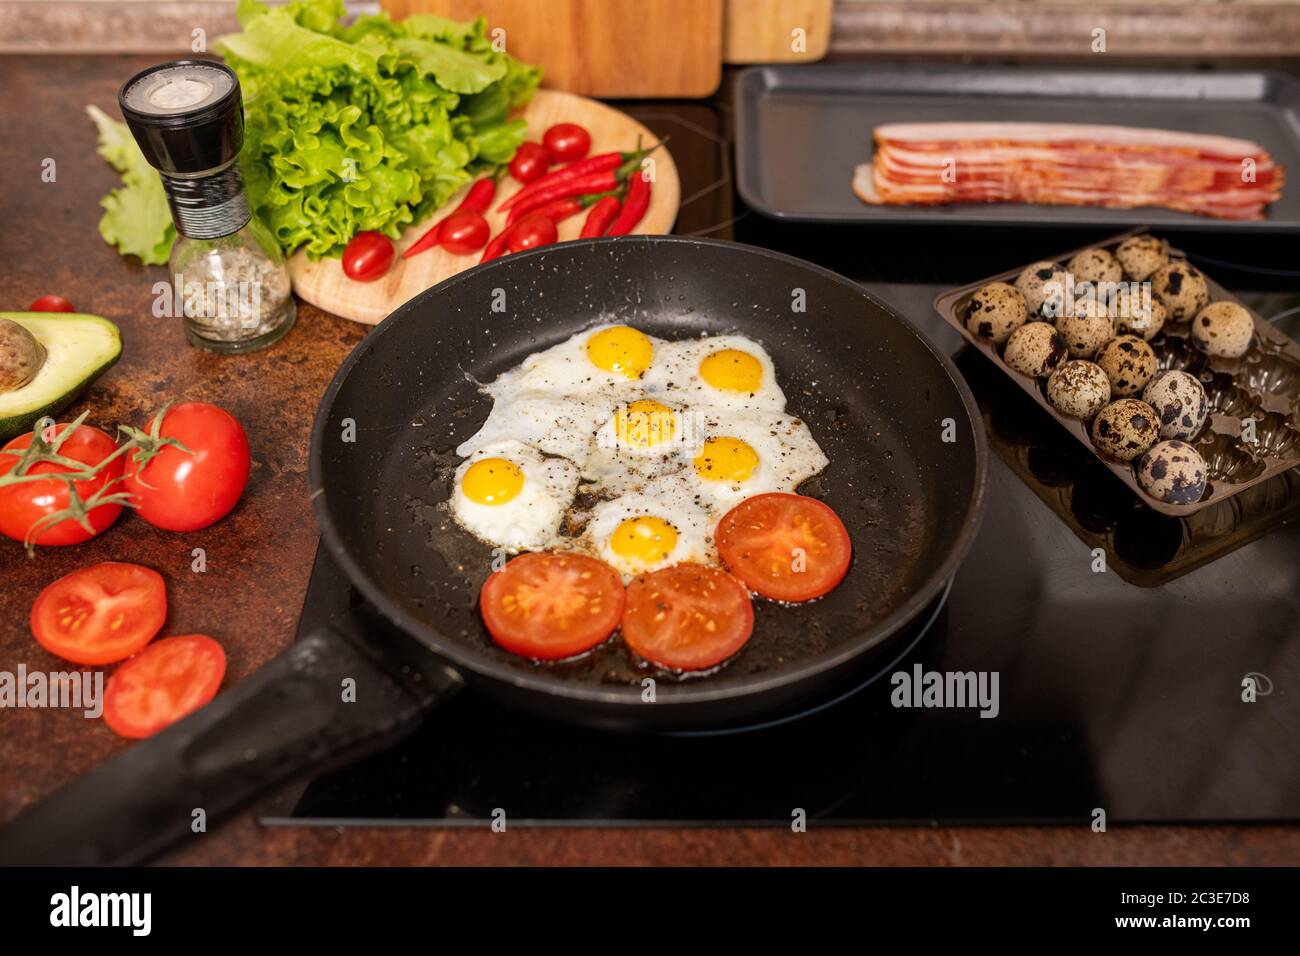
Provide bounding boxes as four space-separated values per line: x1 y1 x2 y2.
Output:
451 440 579 551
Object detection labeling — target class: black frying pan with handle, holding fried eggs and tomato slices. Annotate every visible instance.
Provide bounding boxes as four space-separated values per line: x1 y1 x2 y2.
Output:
0 237 987 864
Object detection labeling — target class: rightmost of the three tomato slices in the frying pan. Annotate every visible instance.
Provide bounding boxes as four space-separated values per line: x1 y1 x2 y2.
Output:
715 492 853 601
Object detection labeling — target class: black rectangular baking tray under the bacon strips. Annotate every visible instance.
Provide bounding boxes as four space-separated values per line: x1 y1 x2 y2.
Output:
736 64 1300 233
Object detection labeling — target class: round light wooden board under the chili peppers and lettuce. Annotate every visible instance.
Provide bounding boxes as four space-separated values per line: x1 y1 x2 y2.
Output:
289 90 681 325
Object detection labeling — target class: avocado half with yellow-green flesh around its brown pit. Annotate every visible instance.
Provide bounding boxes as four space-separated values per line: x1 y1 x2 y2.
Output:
0 312 122 440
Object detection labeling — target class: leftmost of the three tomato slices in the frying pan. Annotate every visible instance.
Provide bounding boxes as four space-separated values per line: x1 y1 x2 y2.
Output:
478 551 623 661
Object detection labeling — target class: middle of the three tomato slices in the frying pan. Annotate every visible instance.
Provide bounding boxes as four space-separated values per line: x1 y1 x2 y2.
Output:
623 563 754 671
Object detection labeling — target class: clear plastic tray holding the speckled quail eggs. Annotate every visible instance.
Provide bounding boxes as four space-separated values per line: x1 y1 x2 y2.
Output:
935 229 1300 516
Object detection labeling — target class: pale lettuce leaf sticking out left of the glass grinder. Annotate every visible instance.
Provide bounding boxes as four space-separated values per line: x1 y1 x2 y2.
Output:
86 107 176 265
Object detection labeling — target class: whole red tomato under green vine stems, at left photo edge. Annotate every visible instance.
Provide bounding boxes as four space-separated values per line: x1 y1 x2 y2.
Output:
0 423 122 545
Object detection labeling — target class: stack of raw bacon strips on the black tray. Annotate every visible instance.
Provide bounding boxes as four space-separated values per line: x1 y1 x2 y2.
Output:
853 122 1286 220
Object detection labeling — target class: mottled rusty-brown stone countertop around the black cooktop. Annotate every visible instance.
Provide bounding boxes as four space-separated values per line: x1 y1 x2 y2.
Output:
0 56 1300 865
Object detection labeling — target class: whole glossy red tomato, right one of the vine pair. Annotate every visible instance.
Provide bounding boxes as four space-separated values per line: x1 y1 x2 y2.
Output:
125 402 248 531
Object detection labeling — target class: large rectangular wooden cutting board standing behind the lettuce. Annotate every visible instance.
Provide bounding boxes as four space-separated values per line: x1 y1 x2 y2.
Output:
381 0 723 98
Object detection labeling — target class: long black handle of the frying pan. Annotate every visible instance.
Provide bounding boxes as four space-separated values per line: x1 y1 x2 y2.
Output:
0 628 462 866
